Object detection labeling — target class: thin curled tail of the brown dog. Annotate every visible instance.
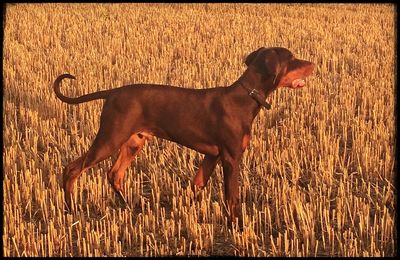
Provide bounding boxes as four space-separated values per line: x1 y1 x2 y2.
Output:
53 74 112 104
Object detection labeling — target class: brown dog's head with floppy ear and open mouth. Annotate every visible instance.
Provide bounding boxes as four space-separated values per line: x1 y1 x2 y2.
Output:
245 47 315 88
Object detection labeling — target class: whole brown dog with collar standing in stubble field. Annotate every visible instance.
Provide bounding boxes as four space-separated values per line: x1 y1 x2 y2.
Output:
54 48 315 225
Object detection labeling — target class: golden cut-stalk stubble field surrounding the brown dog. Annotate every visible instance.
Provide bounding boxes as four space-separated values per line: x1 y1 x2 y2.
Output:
2 4 397 256
